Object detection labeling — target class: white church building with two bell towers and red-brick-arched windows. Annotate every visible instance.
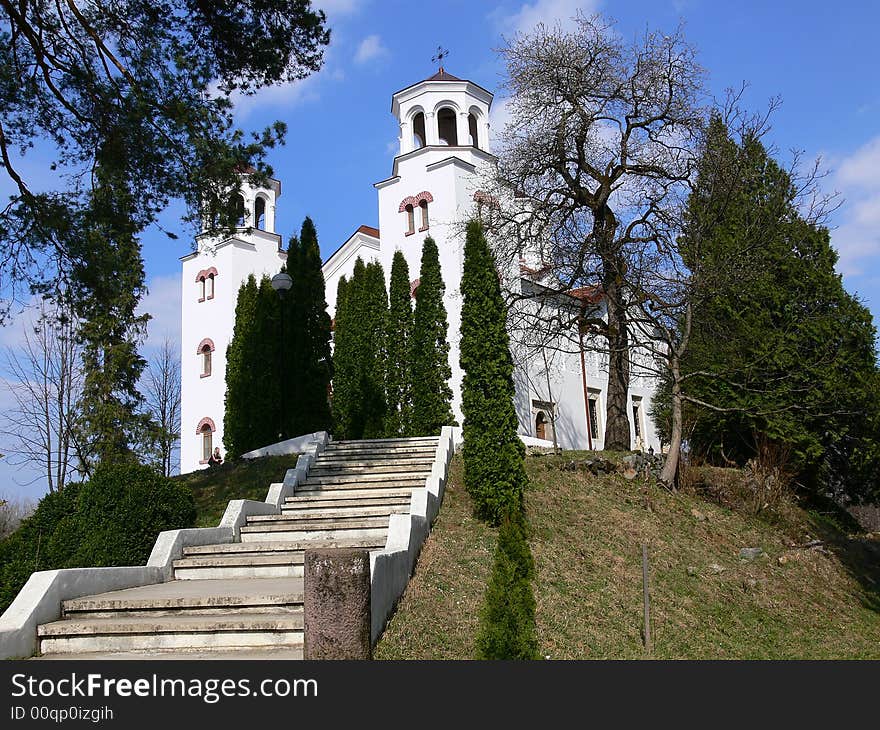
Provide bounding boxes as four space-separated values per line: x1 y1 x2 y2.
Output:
181 68 660 473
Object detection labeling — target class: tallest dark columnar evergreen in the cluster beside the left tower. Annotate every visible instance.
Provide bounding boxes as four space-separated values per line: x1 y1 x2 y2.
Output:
283 217 333 437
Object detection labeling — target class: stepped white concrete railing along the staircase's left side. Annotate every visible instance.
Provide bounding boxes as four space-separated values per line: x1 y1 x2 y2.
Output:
0 431 329 659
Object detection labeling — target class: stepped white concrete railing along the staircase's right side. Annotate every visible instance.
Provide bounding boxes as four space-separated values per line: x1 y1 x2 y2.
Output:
370 426 456 644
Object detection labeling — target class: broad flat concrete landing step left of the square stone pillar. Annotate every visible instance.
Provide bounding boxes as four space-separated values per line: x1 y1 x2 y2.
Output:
61 578 303 619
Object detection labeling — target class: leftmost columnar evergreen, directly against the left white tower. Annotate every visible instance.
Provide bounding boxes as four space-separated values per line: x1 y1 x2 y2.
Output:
223 274 258 459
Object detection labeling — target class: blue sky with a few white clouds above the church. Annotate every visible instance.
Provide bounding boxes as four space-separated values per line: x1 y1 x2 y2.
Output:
0 0 880 496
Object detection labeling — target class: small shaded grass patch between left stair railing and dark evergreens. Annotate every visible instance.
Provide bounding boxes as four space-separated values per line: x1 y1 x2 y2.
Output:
175 454 297 527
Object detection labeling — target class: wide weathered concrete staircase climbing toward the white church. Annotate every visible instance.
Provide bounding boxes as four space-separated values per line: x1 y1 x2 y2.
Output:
37 438 438 659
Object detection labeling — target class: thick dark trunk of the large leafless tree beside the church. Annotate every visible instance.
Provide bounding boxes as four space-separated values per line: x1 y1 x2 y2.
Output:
603 255 631 451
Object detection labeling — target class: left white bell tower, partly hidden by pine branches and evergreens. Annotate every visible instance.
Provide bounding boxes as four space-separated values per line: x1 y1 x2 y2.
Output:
180 169 287 474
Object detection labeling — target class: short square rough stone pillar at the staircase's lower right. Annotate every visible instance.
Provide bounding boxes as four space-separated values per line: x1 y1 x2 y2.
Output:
303 548 372 659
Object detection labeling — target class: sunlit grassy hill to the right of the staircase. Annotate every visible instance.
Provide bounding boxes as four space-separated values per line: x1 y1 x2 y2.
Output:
375 453 880 659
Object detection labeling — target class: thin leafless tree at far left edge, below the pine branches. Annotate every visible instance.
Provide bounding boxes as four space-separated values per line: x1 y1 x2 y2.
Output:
0 302 82 492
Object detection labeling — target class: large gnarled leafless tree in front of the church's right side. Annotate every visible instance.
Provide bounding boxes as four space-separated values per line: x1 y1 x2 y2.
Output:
484 14 703 449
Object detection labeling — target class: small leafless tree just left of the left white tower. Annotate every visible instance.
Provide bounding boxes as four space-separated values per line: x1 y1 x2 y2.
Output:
143 338 181 476
